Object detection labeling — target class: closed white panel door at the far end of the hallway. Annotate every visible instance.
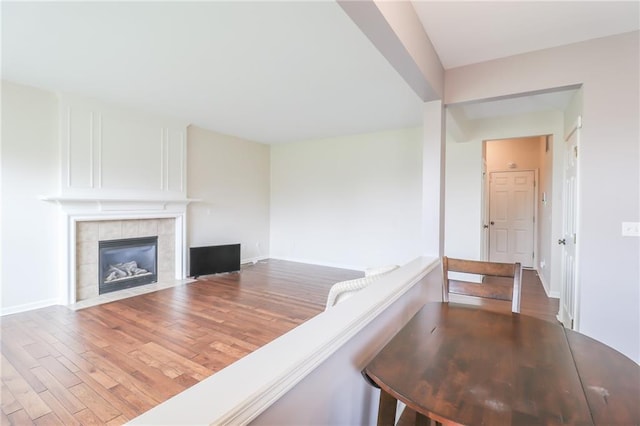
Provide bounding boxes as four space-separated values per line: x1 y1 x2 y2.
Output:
489 171 535 267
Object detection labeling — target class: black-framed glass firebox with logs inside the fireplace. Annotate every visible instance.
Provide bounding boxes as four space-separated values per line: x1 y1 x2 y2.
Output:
98 236 158 294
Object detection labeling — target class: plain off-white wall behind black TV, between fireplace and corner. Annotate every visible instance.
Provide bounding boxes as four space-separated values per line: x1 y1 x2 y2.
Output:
187 126 270 261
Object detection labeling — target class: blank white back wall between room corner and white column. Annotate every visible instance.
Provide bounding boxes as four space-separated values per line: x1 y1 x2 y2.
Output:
271 128 422 269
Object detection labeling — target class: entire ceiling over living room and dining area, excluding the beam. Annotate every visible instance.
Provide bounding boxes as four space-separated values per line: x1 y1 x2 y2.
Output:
1 1 640 143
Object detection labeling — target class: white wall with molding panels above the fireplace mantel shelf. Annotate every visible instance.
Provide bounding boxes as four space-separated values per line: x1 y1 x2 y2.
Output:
59 95 187 198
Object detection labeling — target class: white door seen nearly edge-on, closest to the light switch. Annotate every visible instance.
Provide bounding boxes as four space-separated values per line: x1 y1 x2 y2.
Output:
558 121 580 330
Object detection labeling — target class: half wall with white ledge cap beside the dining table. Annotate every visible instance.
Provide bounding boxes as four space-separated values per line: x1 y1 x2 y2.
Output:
129 257 442 425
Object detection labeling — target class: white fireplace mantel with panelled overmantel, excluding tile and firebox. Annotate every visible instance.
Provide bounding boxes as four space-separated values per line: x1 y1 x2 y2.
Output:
40 93 205 304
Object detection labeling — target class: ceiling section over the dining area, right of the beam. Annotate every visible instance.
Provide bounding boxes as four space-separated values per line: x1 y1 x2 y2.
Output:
412 0 640 69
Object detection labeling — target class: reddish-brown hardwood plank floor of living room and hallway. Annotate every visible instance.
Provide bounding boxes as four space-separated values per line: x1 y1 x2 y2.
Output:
0 260 557 425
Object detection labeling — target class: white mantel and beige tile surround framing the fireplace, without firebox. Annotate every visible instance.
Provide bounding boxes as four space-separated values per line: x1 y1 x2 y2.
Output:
43 196 195 305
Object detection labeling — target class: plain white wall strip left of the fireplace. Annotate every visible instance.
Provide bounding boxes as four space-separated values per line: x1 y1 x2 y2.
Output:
0 81 61 314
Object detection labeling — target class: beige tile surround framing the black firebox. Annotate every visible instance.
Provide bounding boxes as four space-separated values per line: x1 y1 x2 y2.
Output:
76 218 175 301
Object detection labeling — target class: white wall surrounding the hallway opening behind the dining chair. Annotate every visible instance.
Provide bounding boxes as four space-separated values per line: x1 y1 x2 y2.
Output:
445 111 564 297
